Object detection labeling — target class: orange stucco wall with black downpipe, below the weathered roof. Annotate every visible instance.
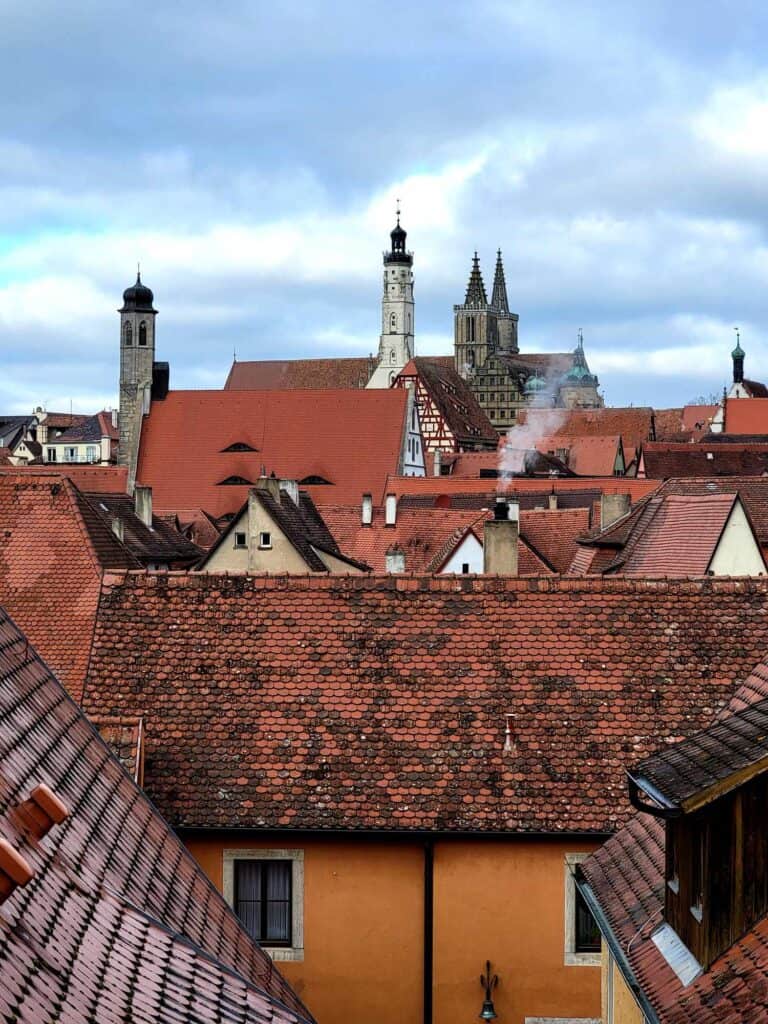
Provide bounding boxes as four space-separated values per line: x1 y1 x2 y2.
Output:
186 834 600 1024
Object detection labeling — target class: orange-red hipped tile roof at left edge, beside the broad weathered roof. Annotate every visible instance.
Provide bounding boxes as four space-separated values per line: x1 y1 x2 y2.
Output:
0 470 139 698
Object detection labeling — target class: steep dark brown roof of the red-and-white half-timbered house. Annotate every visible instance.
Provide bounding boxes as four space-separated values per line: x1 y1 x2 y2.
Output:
398 356 499 449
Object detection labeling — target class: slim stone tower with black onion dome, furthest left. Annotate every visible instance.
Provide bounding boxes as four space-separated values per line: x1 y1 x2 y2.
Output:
118 273 158 481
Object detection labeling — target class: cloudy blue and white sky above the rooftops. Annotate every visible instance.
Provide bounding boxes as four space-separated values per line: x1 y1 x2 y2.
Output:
0 0 768 413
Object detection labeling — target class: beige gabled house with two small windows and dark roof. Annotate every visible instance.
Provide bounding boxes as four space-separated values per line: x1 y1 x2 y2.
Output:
198 476 370 574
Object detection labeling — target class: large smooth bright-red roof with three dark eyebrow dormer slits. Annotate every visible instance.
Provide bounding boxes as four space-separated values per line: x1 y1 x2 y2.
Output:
137 388 415 517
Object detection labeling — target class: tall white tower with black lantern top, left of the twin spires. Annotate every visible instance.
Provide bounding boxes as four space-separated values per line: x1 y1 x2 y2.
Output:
367 207 414 388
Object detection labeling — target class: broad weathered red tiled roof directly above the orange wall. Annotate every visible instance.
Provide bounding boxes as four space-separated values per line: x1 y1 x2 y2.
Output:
83 573 768 833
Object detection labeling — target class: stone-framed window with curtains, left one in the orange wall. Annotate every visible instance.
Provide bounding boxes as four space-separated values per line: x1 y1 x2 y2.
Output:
223 849 304 961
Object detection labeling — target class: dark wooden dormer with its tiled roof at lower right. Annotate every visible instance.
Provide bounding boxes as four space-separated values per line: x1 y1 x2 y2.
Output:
628 699 768 979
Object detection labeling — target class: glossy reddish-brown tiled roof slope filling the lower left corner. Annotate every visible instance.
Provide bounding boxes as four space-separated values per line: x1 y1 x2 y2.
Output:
0 610 310 1024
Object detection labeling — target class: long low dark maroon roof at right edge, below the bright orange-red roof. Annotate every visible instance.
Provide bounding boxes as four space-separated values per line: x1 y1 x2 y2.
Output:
642 442 768 480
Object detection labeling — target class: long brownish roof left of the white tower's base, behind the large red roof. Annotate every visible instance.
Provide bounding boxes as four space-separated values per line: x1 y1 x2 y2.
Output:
224 356 376 391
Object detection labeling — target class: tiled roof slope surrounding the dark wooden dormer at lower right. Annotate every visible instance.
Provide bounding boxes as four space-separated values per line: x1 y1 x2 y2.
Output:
580 662 768 1024
